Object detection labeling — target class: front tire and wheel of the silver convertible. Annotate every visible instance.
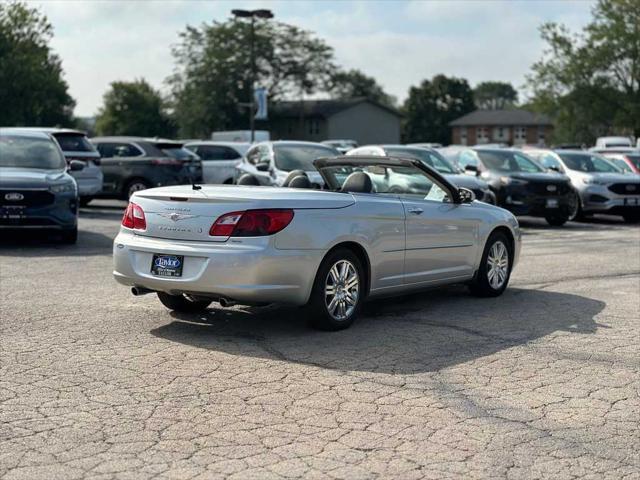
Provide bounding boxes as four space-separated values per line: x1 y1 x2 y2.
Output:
469 232 513 297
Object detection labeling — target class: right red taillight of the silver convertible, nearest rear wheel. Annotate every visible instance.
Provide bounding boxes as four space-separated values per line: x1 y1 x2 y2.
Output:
209 209 293 237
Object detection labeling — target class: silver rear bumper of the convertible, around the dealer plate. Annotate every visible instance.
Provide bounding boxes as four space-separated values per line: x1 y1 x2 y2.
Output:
113 231 324 305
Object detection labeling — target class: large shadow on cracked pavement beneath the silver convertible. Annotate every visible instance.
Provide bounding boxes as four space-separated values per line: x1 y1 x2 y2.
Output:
151 286 606 374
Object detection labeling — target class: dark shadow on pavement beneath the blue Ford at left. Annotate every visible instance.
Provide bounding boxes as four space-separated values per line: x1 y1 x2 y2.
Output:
0 230 117 257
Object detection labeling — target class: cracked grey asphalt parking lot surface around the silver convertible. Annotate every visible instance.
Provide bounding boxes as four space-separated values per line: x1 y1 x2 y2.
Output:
0 202 640 479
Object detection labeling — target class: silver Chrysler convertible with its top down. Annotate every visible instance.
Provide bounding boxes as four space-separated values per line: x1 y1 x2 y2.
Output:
113 157 520 330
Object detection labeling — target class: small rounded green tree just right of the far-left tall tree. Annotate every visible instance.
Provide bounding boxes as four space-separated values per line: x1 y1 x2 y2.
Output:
96 79 175 137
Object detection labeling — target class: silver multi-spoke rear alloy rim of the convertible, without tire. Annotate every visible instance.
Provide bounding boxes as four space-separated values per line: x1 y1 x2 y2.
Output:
324 260 360 321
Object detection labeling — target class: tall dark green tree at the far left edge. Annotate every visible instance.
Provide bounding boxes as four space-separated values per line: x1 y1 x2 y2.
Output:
0 2 75 126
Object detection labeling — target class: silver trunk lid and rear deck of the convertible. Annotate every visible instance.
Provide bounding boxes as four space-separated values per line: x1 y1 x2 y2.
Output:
131 185 354 242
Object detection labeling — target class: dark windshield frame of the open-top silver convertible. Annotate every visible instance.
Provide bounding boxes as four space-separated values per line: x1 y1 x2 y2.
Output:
313 155 462 204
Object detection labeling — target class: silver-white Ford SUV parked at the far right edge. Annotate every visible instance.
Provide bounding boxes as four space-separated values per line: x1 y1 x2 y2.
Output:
527 150 640 222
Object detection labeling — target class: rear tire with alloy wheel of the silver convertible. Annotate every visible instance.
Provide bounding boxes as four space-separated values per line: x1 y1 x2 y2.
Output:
307 248 366 331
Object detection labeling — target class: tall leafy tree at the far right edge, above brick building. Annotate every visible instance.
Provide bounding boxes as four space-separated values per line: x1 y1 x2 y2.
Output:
528 0 640 143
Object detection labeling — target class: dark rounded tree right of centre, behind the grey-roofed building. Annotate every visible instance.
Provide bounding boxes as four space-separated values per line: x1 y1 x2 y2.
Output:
403 75 475 144
